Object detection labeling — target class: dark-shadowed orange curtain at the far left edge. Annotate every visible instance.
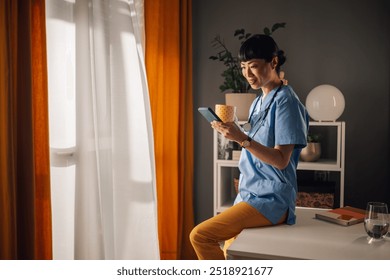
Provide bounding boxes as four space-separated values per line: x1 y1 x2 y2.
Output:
0 0 52 259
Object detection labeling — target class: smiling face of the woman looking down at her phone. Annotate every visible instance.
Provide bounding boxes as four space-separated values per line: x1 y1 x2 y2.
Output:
241 59 276 89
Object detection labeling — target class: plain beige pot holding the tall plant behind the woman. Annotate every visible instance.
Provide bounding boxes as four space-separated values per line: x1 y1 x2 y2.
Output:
225 93 256 121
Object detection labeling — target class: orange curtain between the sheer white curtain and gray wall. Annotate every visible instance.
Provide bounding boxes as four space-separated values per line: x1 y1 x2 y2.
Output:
144 0 195 259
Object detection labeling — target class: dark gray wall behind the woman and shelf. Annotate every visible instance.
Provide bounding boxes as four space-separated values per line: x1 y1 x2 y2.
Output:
193 0 390 223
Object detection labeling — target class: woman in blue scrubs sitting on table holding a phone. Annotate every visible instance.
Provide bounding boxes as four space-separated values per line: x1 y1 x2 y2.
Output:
190 35 309 259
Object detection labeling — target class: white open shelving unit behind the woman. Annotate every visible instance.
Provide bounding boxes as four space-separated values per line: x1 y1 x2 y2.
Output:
213 121 345 215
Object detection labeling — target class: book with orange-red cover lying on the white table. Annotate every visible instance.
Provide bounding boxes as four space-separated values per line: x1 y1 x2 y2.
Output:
315 206 366 226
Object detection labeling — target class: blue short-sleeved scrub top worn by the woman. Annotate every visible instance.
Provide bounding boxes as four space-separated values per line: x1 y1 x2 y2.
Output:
235 86 309 224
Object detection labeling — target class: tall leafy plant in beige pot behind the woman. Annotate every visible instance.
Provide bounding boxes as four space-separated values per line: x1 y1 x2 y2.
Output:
209 22 286 120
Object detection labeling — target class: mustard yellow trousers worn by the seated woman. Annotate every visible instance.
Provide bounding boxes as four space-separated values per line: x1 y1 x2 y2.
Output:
190 202 287 260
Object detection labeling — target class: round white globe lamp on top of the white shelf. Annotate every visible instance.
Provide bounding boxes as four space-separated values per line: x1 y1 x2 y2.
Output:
306 85 345 121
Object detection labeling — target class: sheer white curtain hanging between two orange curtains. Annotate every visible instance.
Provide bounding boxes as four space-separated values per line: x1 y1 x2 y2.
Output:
46 0 159 259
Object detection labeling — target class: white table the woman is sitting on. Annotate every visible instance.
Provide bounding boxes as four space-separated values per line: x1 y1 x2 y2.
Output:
227 208 390 260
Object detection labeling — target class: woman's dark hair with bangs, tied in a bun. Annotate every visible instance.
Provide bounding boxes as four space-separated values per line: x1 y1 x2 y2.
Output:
238 34 286 73
